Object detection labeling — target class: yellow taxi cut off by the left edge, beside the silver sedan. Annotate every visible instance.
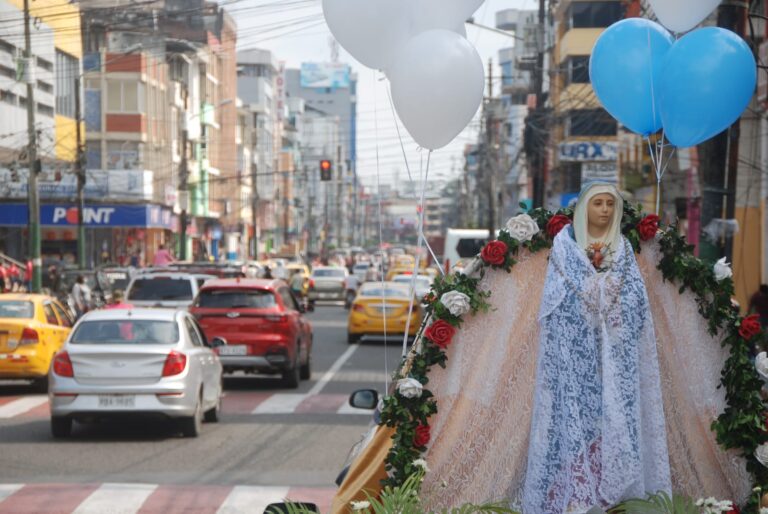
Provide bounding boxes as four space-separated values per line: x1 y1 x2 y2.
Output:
0 293 74 389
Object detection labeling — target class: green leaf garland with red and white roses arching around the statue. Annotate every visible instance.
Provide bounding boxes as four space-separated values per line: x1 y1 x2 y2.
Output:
381 202 768 512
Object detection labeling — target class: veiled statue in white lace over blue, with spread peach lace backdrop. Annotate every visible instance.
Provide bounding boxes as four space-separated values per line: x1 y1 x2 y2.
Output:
330 183 751 514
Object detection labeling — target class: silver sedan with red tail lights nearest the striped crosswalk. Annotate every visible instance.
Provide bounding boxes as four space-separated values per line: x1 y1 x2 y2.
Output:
48 309 222 437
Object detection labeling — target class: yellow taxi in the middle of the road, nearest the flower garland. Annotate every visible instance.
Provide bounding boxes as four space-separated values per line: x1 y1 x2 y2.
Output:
347 282 422 344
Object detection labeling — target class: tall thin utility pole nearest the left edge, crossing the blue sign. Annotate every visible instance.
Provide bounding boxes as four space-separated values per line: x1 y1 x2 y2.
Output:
24 0 43 293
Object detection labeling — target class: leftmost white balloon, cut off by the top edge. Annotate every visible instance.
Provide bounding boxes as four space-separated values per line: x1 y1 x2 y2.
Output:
323 0 412 69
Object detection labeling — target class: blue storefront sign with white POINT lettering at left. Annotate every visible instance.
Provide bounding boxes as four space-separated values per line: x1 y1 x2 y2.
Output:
0 204 174 230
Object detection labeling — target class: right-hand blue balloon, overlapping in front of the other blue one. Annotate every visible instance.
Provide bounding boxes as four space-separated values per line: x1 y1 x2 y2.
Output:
660 27 757 148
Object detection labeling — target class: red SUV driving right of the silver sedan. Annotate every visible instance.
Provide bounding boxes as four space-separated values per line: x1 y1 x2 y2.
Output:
189 278 312 388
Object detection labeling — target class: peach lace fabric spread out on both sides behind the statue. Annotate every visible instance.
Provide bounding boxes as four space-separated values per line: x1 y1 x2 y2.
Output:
422 235 751 508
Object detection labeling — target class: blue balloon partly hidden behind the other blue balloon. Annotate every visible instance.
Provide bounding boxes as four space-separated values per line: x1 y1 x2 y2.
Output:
589 18 675 136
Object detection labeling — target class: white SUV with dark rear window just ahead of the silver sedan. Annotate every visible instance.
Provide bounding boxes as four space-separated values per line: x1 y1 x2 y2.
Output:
125 272 200 309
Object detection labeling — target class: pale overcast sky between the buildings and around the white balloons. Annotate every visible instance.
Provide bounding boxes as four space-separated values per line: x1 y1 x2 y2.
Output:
234 0 538 188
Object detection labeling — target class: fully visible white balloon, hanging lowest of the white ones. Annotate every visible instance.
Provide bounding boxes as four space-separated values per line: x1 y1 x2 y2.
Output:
388 30 485 150
